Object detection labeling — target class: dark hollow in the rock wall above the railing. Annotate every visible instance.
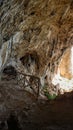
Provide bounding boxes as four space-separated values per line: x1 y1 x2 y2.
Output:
20 51 39 75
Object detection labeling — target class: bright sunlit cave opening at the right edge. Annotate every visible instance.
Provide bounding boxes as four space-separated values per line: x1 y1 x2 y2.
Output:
52 46 73 94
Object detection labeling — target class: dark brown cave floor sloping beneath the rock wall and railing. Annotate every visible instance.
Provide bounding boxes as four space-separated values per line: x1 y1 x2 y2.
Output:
0 81 73 130
